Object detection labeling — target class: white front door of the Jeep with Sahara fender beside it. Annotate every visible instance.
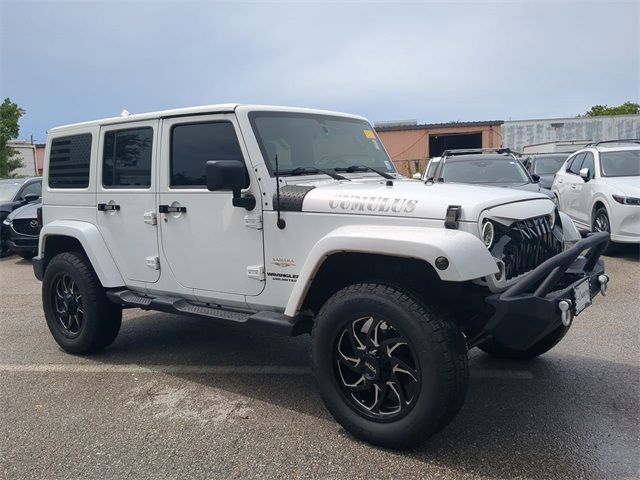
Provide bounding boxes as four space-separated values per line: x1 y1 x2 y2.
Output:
158 114 264 298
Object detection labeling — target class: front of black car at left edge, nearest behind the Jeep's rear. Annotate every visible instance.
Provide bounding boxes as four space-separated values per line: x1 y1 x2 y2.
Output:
2 202 42 258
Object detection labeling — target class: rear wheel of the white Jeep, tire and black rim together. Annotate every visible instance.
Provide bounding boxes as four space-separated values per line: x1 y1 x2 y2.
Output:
42 252 122 354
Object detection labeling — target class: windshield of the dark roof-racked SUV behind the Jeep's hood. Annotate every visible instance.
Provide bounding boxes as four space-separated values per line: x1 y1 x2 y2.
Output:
440 159 530 184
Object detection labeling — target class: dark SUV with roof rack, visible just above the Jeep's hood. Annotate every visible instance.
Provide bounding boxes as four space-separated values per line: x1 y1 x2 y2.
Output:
425 148 554 200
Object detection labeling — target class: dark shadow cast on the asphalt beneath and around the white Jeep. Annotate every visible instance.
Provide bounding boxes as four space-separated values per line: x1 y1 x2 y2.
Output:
92 313 640 478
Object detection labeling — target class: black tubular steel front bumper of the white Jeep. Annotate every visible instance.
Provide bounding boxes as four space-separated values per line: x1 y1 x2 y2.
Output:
480 233 609 350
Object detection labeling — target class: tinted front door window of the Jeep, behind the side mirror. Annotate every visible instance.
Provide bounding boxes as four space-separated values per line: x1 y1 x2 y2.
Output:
170 122 244 188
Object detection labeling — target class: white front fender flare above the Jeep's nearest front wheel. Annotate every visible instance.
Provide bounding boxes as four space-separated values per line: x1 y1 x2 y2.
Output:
285 225 498 316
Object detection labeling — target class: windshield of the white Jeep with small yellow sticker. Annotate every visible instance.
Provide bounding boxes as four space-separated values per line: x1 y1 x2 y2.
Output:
249 112 396 175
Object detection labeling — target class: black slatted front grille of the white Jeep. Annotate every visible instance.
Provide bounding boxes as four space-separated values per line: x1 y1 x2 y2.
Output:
491 216 563 280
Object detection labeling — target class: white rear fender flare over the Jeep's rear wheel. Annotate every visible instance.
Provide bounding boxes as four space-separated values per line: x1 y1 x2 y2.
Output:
39 220 125 288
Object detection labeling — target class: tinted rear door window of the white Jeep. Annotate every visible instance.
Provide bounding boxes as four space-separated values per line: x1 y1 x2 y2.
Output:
102 127 153 188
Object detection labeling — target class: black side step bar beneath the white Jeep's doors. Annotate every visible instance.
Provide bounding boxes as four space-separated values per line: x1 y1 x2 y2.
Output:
107 290 311 336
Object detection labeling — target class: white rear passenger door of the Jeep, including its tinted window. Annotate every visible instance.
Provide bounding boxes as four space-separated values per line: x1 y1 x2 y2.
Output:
97 120 160 286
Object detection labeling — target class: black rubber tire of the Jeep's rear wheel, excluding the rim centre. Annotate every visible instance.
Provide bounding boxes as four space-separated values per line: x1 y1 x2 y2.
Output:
42 251 122 355
